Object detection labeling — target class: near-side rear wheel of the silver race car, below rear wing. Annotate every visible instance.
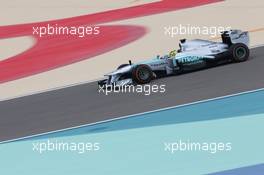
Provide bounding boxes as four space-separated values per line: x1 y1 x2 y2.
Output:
229 43 249 62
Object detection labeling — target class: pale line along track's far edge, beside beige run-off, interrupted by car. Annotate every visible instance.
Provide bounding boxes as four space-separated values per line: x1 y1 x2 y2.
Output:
0 44 264 102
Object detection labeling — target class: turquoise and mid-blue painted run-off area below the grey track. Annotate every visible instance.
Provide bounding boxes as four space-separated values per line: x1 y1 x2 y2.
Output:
0 91 264 175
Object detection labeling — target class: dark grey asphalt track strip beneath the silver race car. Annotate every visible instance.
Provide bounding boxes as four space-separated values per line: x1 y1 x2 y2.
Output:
0 47 264 141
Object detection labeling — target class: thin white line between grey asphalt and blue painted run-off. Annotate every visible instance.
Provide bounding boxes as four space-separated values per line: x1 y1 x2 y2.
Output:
0 88 264 144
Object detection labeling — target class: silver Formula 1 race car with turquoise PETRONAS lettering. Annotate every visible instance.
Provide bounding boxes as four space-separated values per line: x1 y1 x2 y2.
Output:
98 30 250 86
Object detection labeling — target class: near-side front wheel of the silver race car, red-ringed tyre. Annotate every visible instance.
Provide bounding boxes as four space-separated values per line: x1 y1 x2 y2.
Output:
132 64 153 84
